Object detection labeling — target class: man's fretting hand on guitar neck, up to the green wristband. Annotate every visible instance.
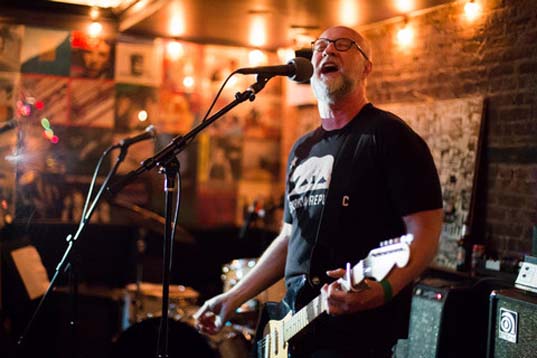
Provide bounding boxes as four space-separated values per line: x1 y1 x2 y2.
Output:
321 268 384 316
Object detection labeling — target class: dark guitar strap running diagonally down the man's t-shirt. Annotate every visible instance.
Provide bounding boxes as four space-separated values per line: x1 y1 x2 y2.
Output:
308 112 368 286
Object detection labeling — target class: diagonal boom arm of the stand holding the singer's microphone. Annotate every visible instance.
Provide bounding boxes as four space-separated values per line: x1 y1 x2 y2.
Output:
107 75 273 194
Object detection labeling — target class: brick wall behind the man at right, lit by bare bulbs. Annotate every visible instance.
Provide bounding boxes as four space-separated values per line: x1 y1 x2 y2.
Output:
361 0 537 256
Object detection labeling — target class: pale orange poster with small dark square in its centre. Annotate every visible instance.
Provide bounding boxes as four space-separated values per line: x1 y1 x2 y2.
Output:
115 40 162 87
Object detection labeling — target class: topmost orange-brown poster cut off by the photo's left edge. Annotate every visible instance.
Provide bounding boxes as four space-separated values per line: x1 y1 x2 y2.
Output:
0 24 24 72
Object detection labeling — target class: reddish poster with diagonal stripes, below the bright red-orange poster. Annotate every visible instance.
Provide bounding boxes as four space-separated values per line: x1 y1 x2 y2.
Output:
70 79 115 128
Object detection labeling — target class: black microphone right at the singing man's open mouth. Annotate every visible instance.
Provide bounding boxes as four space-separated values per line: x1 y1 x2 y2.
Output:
236 57 313 82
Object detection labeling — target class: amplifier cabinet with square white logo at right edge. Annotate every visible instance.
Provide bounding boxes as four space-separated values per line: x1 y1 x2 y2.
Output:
487 289 537 358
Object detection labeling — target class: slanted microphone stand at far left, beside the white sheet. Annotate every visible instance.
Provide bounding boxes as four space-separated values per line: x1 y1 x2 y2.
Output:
17 144 128 356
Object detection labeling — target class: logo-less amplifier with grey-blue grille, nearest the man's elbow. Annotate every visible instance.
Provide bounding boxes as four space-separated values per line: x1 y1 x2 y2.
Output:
404 279 488 358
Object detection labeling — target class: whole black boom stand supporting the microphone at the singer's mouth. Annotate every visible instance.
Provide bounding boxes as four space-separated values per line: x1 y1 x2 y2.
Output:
108 74 273 358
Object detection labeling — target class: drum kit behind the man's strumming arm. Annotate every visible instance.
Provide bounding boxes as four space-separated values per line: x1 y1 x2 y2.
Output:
111 258 260 358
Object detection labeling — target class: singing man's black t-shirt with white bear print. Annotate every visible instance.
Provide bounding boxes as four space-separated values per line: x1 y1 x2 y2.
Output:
284 104 442 352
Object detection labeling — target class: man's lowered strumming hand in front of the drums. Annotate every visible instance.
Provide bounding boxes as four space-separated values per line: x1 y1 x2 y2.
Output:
193 292 239 334
